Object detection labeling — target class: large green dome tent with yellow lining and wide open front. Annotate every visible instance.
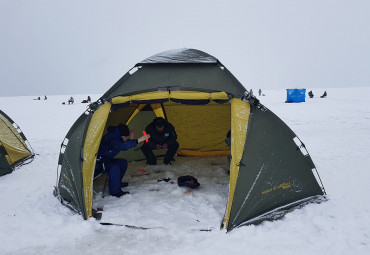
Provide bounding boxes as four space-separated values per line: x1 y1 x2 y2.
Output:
54 49 325 231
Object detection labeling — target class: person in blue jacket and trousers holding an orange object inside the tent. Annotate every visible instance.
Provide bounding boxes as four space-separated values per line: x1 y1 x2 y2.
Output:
97 124 150 197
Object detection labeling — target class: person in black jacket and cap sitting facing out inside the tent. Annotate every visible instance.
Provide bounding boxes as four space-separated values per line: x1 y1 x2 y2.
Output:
141 117 179 165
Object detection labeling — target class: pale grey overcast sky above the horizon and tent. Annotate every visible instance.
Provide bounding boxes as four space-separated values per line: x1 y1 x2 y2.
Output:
0 0 370 96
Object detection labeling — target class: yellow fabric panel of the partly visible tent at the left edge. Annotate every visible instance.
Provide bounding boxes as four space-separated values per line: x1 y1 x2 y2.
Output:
0 115 31 165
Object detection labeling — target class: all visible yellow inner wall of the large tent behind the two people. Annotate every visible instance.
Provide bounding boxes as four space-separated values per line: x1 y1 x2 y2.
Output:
107 101 230 157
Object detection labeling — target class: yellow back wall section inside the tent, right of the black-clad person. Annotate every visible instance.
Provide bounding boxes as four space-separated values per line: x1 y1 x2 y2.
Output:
163 102 230 151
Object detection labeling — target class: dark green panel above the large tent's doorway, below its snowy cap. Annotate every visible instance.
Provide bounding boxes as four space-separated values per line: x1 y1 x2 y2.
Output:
102 64 245 99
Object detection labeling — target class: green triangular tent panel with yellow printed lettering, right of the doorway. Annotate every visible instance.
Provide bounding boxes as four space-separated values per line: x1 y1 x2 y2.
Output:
228 108 323 230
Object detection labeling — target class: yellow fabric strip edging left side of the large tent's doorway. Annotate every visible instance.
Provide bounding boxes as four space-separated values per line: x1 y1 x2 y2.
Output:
82 103 111 218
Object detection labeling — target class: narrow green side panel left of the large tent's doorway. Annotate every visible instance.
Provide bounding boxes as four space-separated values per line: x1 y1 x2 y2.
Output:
58 114 92 218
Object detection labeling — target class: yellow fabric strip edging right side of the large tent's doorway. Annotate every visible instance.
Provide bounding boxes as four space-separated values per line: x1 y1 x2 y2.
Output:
223 98 250 228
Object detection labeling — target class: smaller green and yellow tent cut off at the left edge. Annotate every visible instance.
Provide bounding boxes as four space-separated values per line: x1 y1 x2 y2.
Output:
0 110 35 176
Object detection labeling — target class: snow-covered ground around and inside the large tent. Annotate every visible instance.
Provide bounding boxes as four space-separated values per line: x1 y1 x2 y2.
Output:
0 87 370 255
